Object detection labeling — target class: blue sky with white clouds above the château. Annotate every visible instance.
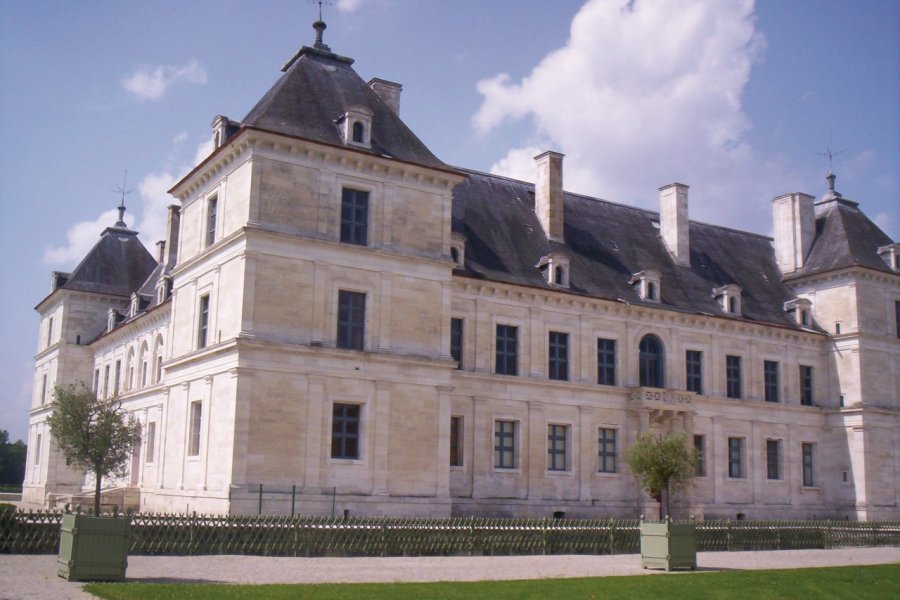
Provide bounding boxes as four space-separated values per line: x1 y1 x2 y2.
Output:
0 0 900 439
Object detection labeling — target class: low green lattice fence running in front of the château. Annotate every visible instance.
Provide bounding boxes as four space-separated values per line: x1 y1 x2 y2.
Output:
0 511 900 556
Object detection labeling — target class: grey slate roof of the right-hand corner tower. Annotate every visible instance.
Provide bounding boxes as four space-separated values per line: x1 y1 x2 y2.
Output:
788 195 893 279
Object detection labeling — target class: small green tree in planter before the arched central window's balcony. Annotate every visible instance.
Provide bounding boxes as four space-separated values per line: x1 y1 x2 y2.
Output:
625 431 699 520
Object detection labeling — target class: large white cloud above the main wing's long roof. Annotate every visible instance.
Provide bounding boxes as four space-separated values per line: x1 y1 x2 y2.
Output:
472 0 791 228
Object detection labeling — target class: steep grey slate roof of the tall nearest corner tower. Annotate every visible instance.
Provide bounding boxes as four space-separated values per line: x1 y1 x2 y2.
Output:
243 46 447 169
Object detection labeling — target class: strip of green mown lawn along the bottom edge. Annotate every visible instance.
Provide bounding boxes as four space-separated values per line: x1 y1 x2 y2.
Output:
85 564 900 600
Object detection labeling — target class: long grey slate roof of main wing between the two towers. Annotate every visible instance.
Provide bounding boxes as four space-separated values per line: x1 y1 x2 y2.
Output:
453 169 798 328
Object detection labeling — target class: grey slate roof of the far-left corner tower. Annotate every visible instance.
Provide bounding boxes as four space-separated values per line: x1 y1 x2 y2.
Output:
60 227 156 296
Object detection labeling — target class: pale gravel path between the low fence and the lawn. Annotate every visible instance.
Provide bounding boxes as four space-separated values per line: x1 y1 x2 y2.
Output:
0 548 900 600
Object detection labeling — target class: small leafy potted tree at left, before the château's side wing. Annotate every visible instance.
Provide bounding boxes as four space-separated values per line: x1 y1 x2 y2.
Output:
47 382 140 515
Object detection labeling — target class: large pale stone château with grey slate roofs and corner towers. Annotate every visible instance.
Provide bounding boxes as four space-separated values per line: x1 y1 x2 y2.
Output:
24 22 900 519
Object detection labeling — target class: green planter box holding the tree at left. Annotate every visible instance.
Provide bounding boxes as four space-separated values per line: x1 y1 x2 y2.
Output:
56 514 131 581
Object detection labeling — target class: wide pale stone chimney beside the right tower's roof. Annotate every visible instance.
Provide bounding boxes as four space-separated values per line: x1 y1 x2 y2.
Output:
772 192 816 275
